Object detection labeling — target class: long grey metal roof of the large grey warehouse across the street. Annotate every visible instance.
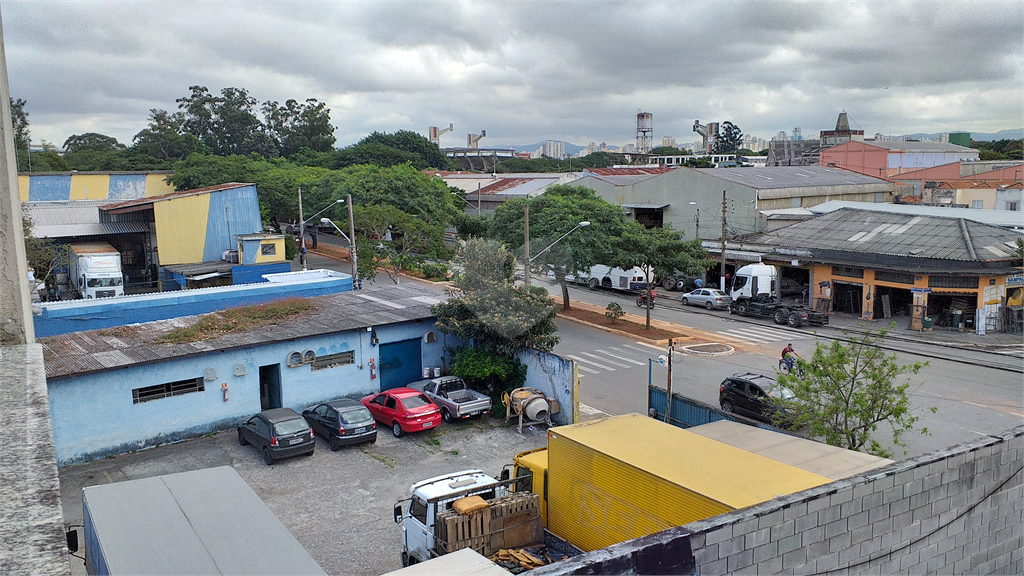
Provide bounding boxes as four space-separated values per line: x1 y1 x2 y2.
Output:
696 166 895 190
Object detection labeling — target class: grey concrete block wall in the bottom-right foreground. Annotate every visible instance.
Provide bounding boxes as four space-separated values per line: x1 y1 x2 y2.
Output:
673 425 1024 576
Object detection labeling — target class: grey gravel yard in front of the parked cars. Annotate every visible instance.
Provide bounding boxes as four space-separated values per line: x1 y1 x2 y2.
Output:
59 419 547 575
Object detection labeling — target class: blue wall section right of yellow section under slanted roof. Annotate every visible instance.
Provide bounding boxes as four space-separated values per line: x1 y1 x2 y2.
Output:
203 186 263 262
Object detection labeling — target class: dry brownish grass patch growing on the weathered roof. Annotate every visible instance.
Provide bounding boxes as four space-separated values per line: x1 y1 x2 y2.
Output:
156 298 316 343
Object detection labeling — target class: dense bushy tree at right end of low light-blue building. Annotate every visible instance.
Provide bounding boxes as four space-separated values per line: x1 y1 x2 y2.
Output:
431 239 558 358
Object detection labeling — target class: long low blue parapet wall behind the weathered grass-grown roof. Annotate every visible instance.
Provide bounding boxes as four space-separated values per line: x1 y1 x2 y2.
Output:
33 274 352 337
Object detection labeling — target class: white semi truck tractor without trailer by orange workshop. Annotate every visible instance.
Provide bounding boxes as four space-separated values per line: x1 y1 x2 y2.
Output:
729 264 828 328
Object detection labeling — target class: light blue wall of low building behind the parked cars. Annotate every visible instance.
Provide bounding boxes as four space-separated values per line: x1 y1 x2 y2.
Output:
47 320 459 466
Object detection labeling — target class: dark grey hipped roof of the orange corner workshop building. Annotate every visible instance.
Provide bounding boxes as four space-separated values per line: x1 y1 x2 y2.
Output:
751 208 1022 263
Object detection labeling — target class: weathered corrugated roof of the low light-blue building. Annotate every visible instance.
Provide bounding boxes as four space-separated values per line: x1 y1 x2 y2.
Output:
37 284 437 378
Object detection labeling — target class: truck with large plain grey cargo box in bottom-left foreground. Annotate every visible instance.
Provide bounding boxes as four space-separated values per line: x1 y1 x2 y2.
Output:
69 466 327 576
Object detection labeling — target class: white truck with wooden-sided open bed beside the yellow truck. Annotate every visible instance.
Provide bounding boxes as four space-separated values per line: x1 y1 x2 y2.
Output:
394 469 545 566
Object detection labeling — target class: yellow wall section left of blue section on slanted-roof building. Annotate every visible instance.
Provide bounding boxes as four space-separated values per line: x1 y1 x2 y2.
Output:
153 194 210 266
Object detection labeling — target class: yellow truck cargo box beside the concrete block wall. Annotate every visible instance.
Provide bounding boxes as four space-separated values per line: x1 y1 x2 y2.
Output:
547 414 831 551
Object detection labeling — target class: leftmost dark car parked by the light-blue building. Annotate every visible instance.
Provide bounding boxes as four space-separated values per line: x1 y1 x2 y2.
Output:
239 408 316 465
